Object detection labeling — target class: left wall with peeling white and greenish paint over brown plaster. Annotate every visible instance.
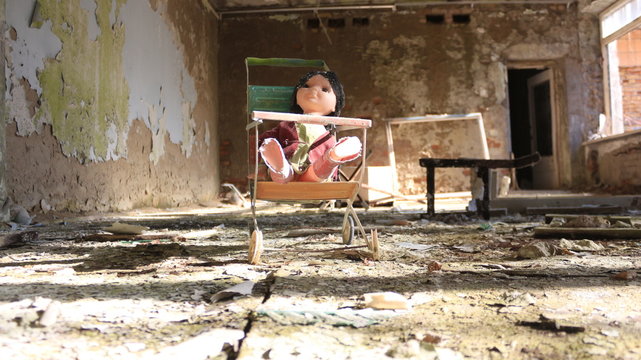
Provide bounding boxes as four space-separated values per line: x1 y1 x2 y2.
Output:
5 0 219 211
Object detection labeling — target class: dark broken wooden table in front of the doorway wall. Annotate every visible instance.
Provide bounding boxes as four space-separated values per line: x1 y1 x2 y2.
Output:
419 153 541 220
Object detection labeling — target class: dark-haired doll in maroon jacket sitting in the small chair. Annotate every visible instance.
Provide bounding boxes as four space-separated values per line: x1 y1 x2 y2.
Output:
258 71 361 184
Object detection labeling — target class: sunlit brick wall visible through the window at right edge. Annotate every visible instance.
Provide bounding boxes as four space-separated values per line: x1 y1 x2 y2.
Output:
619 66 641 131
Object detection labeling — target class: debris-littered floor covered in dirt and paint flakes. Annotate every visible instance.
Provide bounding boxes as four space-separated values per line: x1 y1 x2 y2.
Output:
0 206 641 359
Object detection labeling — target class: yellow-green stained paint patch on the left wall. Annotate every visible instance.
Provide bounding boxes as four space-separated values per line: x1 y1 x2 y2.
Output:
38 0 129 162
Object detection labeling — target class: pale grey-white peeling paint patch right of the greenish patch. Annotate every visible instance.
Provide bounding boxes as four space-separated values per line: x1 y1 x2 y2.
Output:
122 1 197 153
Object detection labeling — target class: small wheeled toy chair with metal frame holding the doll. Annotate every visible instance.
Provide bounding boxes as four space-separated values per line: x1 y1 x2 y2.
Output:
245 57 379 264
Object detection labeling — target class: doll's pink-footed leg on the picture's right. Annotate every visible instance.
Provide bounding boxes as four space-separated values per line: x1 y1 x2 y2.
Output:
298 136 362 182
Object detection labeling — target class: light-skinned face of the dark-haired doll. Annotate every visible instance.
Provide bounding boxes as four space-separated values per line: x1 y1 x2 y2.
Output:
296 75 336 115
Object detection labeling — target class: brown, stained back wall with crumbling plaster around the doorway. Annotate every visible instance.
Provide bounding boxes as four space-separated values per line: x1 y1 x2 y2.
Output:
220 5 602 194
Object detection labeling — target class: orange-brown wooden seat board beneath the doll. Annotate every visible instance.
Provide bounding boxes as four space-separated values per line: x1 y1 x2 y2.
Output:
256 181 359 200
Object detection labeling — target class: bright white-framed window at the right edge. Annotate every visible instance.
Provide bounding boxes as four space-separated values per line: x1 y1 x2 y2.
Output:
601 0 641 135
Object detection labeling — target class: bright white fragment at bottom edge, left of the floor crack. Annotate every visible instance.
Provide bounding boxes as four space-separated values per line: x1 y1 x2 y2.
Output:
147 329 245 360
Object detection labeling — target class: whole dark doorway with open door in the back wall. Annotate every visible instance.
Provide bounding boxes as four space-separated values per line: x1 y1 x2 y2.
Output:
508 68 559 190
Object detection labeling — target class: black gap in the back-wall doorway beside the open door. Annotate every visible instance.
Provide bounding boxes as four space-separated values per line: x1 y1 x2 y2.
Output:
507 69 553 189
